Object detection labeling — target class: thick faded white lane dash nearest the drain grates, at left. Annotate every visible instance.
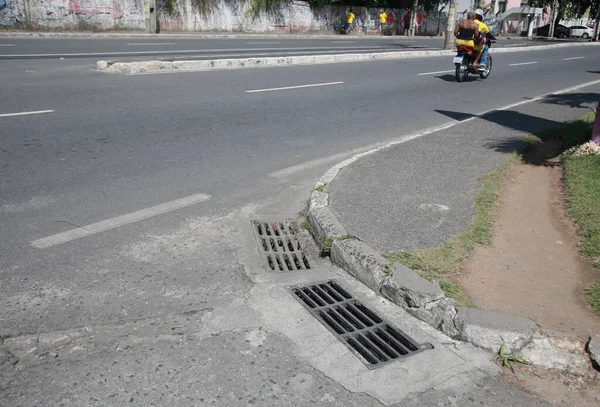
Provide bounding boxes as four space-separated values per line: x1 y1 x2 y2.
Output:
31 194 210 249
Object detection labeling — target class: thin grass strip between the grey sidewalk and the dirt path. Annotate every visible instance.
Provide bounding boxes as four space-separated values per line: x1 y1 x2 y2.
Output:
384 155 516 278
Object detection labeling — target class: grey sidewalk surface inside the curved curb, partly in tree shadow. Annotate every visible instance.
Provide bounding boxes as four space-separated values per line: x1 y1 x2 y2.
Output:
325 84 600 252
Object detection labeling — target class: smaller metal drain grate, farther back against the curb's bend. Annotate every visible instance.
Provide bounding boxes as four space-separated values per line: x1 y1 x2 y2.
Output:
252 221 310 271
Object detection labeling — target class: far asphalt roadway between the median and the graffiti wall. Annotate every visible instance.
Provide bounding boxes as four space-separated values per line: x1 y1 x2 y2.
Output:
0 34 592 60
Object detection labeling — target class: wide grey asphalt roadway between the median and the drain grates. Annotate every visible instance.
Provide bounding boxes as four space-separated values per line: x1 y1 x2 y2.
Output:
0 40 600 406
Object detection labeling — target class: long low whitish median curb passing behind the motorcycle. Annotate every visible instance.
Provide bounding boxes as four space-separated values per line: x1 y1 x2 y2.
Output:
96 42 600 75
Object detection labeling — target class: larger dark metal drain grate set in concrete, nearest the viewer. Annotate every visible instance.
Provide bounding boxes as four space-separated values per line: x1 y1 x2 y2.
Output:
288 280 433 369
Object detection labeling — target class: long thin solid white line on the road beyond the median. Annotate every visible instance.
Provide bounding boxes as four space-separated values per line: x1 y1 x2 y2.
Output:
0 45 382 58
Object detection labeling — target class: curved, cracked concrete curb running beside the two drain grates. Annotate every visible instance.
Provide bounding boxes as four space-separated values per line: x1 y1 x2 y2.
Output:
308 116 600 377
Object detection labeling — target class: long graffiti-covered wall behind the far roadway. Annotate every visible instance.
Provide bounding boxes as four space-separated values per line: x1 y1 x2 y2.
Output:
0 0 454 35
